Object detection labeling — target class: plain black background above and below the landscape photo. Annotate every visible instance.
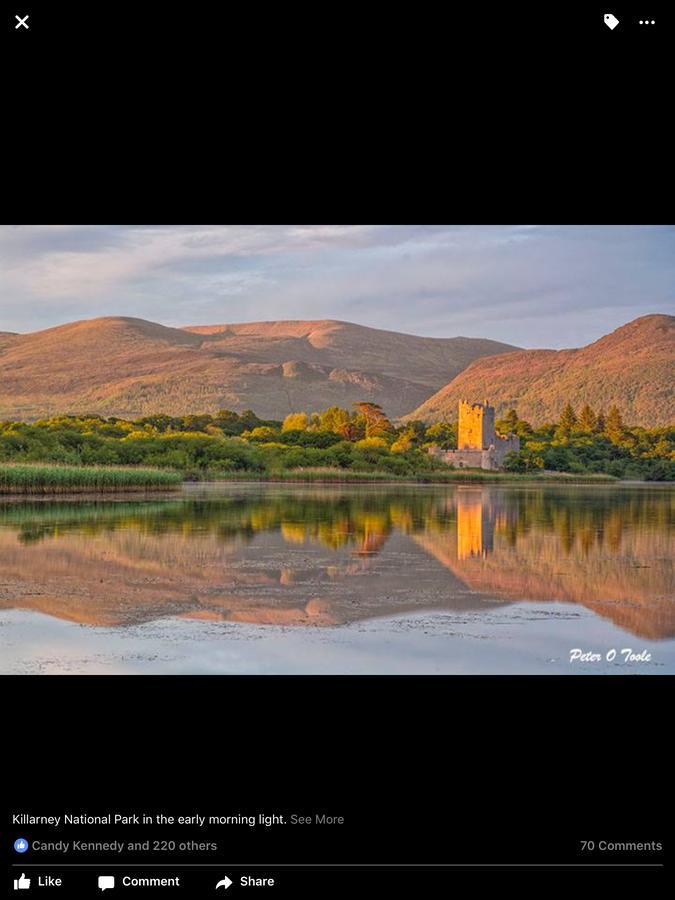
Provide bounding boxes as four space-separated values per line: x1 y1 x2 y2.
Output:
0 2 673 896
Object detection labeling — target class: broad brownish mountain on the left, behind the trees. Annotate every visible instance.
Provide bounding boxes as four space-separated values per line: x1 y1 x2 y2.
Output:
0 317 514 420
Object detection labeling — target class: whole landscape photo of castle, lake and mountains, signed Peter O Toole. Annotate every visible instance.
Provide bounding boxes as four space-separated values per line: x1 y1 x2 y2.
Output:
0 225 675 675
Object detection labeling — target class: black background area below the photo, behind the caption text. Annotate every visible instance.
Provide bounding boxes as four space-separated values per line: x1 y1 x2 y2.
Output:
2 676 671 896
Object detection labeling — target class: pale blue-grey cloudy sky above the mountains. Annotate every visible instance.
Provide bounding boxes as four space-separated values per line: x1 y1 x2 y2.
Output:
0 225 675 348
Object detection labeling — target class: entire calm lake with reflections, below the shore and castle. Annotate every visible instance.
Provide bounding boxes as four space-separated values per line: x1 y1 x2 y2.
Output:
0 484 675 674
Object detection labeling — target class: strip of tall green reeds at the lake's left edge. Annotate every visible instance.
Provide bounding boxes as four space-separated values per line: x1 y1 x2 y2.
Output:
0 463 182 494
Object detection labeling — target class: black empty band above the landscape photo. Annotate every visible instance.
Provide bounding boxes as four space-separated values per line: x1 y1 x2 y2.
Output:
0 0 674 223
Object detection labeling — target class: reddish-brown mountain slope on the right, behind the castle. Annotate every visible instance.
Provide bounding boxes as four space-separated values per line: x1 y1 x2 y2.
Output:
406 315 675 428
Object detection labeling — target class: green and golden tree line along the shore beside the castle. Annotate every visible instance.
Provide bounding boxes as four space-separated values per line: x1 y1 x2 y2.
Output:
0 401 675 481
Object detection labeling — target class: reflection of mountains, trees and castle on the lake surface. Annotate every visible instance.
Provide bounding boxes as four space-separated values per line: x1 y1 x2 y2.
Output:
0 485 675 639
